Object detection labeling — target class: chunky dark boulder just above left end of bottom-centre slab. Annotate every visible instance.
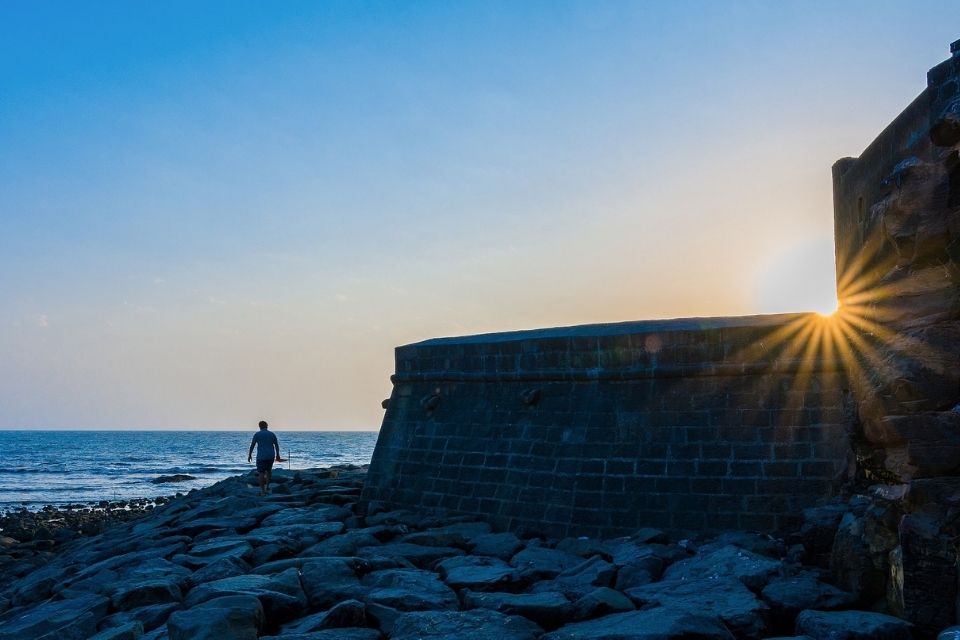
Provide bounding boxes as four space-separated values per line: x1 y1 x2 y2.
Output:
362 569 459 611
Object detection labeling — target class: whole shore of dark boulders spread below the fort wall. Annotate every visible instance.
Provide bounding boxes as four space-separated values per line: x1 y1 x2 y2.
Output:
0 467 952 640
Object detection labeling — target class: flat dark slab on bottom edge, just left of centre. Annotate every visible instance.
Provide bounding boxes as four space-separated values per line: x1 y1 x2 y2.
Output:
390 609 543 640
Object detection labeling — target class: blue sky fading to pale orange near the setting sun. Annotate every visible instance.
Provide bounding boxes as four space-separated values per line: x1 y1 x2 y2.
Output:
0 0 960 430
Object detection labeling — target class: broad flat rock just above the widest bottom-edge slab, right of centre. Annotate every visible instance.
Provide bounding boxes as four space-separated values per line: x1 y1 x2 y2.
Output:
627 577 769 638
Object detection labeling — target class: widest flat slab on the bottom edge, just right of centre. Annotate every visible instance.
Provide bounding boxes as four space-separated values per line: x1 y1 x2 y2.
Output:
541 608 734 640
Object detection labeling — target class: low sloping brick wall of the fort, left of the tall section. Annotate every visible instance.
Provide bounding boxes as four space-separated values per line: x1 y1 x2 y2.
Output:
364 315 852 536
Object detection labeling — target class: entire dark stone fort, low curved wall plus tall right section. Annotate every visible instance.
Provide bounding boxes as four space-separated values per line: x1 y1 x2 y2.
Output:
363 43 960 544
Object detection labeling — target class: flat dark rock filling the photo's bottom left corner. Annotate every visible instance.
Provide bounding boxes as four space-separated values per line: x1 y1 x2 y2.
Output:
0 595 110 640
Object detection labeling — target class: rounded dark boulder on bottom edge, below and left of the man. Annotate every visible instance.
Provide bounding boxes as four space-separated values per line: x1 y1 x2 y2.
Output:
167 595 264 640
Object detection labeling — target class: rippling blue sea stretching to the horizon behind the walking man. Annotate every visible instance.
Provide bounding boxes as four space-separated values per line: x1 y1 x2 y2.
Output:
0 429 377 511
